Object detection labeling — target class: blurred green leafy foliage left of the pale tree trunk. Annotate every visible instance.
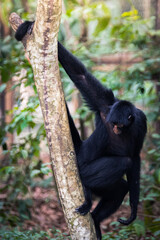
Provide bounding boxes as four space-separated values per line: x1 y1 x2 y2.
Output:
0 16 50 226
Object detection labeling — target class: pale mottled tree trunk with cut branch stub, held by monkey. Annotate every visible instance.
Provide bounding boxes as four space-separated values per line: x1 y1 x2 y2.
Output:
10 0 96 240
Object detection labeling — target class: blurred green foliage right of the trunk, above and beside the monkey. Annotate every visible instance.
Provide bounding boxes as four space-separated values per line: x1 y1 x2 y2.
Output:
61 6 160 239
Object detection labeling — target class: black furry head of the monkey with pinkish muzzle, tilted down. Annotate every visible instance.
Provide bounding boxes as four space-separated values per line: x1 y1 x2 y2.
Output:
106 100 136 135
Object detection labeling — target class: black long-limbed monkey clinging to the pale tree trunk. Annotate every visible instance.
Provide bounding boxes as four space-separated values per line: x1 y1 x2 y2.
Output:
15 21 147 240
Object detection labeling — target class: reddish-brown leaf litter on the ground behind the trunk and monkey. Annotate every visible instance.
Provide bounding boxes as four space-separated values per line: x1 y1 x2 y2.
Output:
23 187 130 233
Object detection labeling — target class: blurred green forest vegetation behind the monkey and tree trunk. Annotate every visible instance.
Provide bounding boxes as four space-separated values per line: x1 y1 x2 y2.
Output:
0 0 160 240
